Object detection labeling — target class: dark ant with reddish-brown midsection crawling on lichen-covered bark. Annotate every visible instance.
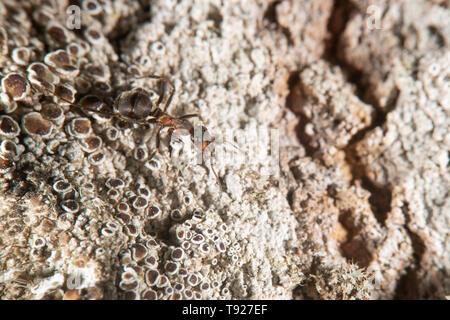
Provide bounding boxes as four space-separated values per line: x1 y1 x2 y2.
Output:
34 75 227 189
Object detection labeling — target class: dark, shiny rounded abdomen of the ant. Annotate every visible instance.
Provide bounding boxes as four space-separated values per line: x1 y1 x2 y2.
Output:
114 88 158 120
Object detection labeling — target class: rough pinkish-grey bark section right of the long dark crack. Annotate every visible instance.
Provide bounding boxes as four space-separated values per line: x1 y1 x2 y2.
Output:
341 1 450 298
